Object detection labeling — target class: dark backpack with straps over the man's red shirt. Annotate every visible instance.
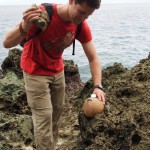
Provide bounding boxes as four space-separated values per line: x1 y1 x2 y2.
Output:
19 3 82 55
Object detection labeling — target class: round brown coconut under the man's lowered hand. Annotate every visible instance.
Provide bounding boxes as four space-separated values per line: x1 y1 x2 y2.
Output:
83 97 104 117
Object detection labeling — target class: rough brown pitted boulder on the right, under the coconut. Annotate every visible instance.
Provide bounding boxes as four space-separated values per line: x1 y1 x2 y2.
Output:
78 53 150 150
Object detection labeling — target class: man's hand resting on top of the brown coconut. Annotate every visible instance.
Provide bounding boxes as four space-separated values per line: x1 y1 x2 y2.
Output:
93 88 106 104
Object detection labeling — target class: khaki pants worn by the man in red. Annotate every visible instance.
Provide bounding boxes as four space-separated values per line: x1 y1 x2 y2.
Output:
23 71 65 150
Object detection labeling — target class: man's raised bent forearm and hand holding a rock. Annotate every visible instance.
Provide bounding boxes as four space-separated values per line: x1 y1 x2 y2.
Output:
3 7 41 48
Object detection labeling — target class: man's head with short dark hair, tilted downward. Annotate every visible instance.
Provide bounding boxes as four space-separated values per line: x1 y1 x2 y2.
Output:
68 0 101 24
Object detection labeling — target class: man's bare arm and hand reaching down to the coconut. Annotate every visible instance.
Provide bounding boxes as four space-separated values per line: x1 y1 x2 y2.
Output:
82 41 105 104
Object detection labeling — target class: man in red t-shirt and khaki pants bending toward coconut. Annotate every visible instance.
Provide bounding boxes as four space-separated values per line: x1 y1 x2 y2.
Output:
3 0 105 150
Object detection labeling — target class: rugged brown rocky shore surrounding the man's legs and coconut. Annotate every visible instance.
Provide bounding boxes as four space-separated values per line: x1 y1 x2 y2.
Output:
0 49 150 150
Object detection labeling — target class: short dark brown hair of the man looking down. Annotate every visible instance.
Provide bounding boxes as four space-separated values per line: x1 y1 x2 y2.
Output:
75 0 101 9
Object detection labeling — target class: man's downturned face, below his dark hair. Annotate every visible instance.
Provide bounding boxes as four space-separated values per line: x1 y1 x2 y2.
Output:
69 0 95 24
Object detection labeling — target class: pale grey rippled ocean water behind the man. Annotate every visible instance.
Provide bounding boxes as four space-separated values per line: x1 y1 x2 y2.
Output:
0 4 150 82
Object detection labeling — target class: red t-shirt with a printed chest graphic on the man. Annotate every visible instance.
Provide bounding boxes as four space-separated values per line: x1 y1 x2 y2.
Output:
21 4 92 75
